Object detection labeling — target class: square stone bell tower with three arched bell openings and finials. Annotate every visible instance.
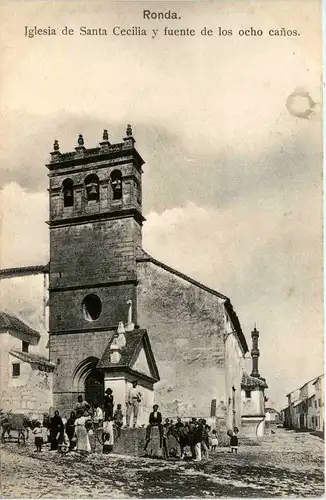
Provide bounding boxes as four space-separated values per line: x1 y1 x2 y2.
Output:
47 125 144 408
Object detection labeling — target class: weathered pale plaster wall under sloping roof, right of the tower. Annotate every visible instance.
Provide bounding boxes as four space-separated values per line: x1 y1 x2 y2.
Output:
137 262 225 417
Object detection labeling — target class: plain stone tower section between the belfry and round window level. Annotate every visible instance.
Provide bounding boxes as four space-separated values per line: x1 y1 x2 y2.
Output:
50 217 140 288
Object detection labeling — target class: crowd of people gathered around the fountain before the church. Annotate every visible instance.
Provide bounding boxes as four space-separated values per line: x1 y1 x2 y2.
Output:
26 381 239 462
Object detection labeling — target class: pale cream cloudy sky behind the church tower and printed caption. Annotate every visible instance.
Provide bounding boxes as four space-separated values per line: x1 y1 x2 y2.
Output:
0 0 323 408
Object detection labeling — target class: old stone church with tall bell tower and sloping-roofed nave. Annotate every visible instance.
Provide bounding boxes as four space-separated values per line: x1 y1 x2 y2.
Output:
0 125 267 433
